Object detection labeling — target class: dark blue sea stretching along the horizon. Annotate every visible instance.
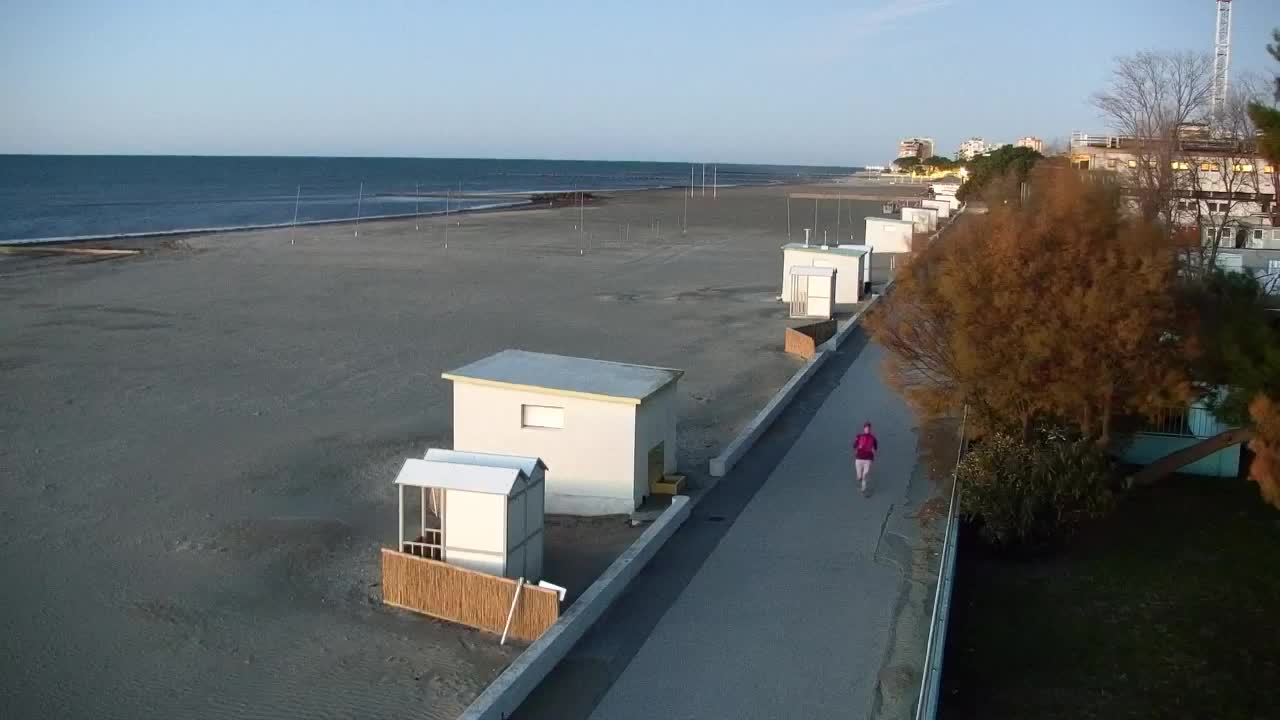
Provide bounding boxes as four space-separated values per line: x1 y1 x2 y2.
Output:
0 155 855 242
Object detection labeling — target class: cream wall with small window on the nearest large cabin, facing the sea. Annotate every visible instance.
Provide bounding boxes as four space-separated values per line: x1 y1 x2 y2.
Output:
453 382 645 515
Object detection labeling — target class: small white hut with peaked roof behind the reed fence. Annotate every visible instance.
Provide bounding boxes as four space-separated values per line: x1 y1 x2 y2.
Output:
396 450 547 583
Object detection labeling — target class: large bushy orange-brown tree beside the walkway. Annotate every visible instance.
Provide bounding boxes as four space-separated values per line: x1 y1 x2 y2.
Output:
868 162 1190 445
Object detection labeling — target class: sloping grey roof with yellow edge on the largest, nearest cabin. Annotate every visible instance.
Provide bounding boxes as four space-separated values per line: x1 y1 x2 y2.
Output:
443 350 685 405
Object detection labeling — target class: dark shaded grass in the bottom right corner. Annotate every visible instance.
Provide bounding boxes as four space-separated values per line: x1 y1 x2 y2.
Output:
941 478 1280 720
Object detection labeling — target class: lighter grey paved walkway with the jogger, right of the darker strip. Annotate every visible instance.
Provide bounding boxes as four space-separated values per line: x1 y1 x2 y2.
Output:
591 345 916 720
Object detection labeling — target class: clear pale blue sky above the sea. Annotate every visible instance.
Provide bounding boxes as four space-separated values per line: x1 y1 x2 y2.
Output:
0 0 1280 165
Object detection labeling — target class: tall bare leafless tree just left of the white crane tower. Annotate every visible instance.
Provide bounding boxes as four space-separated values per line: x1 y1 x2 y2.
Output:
1092 51 1213 226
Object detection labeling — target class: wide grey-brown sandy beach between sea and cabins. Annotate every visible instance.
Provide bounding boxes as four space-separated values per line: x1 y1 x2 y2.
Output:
0 178 919 719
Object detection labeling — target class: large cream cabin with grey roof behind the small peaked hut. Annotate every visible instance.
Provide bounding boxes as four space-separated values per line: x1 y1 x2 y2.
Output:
444 350 684 515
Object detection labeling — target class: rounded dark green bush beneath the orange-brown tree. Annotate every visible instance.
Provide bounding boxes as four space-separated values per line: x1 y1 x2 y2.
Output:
956 432 1115 548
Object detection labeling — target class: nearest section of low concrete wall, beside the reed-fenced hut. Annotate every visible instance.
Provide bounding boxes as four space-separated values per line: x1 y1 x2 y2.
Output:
458 496 690 720
